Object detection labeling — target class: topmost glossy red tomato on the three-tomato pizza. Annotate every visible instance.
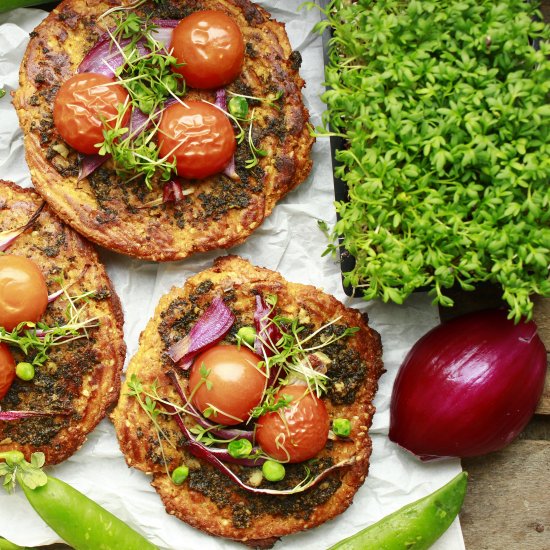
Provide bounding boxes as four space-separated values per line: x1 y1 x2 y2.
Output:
170 10 244 89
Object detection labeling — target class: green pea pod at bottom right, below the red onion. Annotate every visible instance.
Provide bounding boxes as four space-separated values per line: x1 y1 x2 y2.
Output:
329 472 468 550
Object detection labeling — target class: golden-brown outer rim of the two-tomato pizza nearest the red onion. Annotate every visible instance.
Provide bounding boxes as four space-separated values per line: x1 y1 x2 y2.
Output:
112 256 383 547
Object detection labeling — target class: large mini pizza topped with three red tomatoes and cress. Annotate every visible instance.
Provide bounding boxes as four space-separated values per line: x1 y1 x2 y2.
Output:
14 0 313 261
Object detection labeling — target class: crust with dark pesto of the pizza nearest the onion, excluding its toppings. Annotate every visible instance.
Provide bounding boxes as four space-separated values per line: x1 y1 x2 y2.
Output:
112 256 383 548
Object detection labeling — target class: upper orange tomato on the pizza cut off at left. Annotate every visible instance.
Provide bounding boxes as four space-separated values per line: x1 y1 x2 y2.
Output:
0 254 48 331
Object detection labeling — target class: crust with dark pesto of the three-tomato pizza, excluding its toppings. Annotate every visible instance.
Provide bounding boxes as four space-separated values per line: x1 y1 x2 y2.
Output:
14 0 314 261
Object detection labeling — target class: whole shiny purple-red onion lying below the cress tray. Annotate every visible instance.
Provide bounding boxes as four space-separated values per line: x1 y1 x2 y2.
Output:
389 309 546 460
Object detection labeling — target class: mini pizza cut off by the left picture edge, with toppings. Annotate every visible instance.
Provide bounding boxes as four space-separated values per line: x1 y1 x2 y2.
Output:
0 180 126 464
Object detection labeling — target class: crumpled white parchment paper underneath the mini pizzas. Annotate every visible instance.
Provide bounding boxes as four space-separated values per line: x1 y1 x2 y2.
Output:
0 5 464 550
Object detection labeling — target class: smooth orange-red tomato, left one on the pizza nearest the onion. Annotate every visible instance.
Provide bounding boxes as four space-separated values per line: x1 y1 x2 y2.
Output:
189 345 266 426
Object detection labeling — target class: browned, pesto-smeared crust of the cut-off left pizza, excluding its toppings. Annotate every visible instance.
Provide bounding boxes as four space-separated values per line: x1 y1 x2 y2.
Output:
0 180 126 464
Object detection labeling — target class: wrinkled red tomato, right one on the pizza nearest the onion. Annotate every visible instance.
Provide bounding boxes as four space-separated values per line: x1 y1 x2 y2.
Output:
256 385 330 462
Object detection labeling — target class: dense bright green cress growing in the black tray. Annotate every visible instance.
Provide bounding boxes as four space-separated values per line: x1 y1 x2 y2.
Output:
308 0 550 321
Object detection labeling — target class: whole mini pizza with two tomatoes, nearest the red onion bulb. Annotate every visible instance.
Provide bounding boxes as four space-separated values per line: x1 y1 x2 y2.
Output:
112 256 382 548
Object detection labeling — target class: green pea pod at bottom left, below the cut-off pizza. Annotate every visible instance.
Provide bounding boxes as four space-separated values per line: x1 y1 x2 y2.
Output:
18 475 158 550
